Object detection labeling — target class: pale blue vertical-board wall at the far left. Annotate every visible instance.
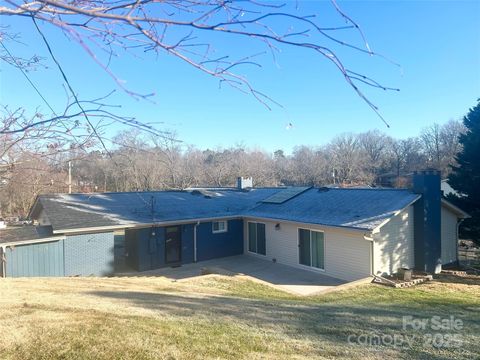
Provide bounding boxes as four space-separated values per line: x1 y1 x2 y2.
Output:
5 240 64 277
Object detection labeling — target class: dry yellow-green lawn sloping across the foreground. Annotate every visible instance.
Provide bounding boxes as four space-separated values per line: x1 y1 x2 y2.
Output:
0 275 480 359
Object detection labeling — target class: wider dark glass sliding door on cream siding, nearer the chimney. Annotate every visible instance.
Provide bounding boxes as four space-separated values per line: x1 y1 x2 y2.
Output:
298 229 325 270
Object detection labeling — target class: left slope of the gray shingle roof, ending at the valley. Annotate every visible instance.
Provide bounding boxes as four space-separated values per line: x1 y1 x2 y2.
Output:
34 188 279 230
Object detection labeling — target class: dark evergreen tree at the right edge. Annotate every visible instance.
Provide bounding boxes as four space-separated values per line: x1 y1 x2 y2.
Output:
448 99 480 244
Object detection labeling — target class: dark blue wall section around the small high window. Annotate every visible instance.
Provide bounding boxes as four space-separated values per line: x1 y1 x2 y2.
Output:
197 220 243 261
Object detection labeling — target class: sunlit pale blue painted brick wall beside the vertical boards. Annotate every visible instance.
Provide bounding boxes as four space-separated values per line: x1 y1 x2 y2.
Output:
64 232 114 276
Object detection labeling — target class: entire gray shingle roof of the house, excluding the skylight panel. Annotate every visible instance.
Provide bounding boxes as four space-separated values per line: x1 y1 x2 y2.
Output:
32 188 419 231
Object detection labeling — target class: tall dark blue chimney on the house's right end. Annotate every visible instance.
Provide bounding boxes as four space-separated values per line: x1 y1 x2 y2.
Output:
413 170 442 273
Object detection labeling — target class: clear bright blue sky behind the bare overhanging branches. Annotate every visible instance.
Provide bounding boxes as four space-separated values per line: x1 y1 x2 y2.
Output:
0 1 480 152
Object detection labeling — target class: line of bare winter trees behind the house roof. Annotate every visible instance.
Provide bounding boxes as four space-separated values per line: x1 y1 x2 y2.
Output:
0 120 464 217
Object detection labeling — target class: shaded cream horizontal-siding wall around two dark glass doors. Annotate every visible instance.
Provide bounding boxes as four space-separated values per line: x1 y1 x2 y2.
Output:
244 219 371 281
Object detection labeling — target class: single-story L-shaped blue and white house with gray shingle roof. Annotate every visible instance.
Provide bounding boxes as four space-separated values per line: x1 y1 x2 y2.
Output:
0 171 468 281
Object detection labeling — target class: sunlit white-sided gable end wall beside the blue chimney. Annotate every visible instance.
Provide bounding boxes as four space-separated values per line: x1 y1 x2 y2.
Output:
373 206 415 274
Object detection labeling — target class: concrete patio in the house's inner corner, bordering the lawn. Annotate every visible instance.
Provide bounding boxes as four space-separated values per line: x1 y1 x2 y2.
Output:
118 255 347 295
